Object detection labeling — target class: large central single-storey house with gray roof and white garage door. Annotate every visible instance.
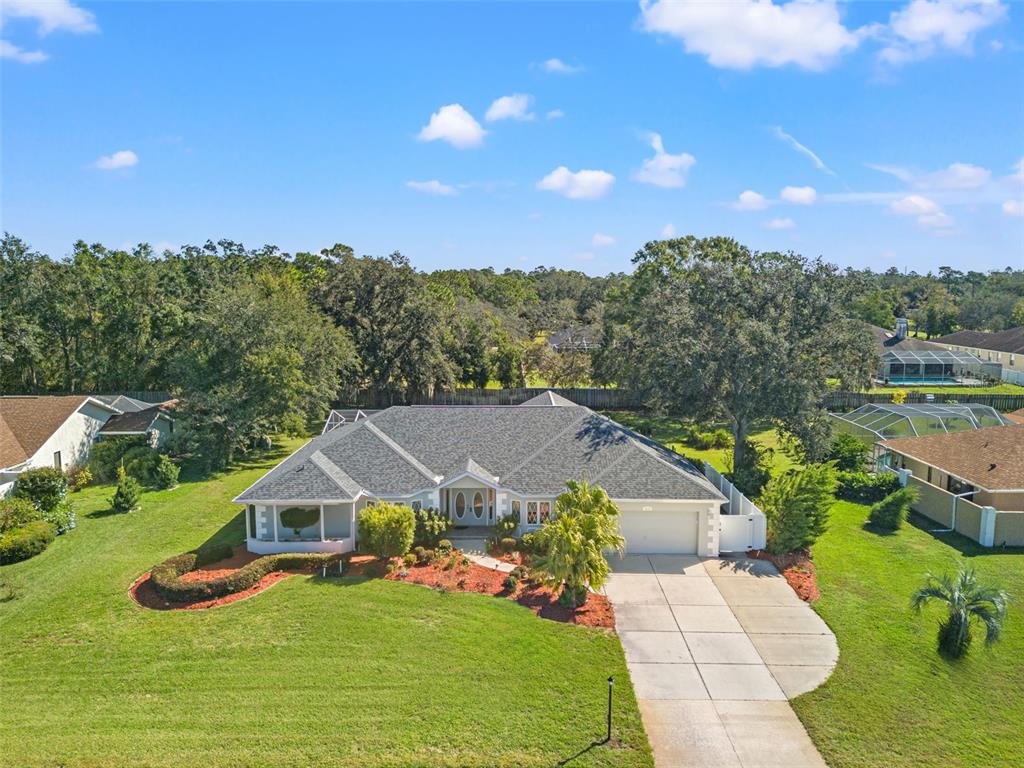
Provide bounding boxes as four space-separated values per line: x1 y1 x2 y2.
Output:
234 392 733 556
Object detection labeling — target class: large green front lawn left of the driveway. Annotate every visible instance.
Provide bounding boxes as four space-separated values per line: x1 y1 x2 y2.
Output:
0 441 651 768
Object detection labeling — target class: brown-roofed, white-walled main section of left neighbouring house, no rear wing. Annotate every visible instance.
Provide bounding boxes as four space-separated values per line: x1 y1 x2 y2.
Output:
0 395 121 497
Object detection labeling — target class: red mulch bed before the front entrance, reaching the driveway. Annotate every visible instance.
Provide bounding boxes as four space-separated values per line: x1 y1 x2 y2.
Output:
385 563 615 629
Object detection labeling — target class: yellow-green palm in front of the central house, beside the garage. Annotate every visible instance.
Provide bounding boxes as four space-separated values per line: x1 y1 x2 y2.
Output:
532 480 626 608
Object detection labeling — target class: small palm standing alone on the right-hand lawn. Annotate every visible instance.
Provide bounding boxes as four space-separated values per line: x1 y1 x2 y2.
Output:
910 565 1010 658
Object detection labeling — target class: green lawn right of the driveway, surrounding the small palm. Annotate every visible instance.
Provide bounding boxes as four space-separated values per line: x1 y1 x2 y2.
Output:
793 502 1024 768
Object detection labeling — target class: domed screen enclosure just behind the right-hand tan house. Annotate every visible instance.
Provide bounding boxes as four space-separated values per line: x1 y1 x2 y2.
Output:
829 402 1010 443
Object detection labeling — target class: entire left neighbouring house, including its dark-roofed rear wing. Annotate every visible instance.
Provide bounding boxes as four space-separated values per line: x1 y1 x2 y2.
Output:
0 395 173 497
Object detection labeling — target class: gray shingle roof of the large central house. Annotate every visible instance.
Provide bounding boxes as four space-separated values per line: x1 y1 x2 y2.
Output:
238 398 722 501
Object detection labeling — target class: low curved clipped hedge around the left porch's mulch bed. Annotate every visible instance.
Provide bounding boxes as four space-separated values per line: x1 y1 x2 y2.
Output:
150 546 338 603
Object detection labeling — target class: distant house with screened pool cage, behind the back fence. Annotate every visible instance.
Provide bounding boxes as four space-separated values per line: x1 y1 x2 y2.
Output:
869 317 1000 384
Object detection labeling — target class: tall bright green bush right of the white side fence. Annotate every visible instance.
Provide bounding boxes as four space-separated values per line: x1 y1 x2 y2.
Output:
761 464 837 555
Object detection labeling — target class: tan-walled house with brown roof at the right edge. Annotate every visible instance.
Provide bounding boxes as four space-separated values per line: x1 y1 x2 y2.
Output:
879 424 1024 547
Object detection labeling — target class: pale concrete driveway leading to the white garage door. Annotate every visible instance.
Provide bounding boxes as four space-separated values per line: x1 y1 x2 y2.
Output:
605 555 839 768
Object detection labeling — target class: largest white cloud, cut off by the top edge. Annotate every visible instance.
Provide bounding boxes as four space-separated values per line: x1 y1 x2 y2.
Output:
640 0 860 70
